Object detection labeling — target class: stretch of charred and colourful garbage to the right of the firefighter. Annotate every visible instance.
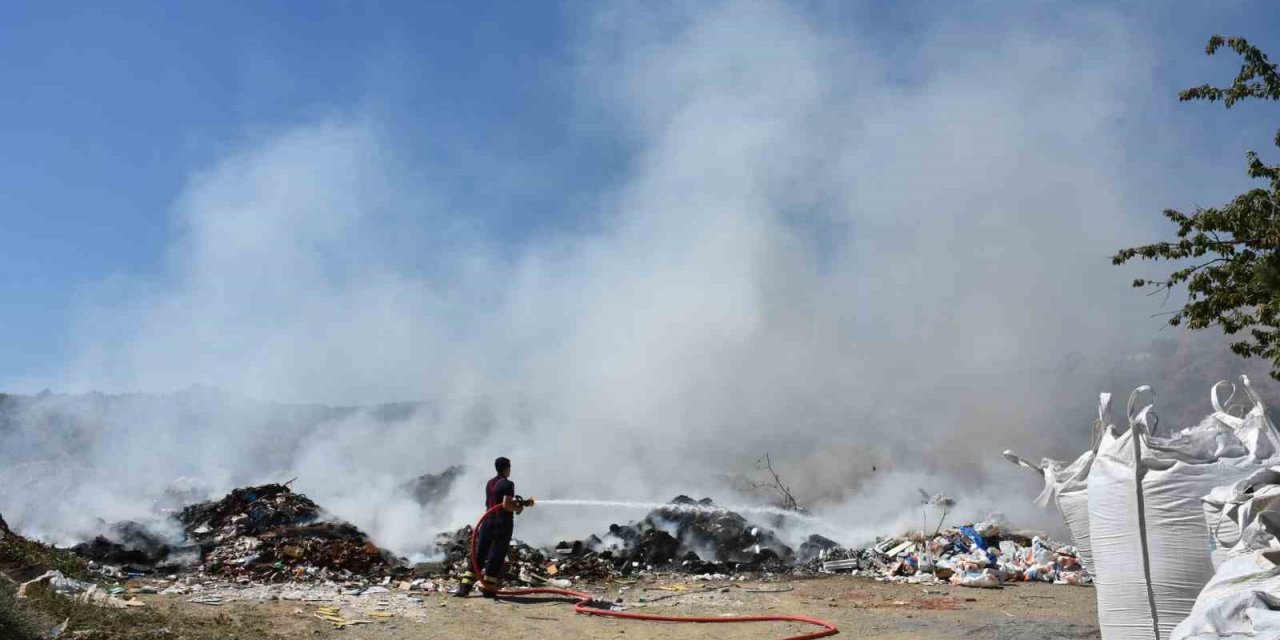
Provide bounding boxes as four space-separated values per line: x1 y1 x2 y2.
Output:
436 495 1092 588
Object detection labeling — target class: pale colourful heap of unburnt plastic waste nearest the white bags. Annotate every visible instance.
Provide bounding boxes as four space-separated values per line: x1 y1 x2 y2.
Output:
804 522 1092 588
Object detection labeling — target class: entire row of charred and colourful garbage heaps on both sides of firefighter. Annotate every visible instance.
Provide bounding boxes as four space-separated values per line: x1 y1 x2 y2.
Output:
22 481 1089 586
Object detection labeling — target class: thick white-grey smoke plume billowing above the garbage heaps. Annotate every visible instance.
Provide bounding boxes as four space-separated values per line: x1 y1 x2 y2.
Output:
0 3 1264 553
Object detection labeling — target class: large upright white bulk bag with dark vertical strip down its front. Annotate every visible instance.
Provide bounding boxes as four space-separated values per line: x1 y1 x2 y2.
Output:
1088 378 1277 640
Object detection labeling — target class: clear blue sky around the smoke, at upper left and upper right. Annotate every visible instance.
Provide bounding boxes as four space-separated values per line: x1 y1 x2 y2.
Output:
0 1 1280 394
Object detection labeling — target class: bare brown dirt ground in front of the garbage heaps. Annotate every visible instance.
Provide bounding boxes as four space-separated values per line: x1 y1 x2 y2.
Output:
142 577 1098 640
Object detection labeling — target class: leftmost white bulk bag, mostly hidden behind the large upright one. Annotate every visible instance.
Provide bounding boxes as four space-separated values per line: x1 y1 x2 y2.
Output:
1005 393 1114 573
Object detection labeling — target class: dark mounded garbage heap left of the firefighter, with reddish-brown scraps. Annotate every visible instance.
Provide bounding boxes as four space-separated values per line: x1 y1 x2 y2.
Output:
178 484 402 582
